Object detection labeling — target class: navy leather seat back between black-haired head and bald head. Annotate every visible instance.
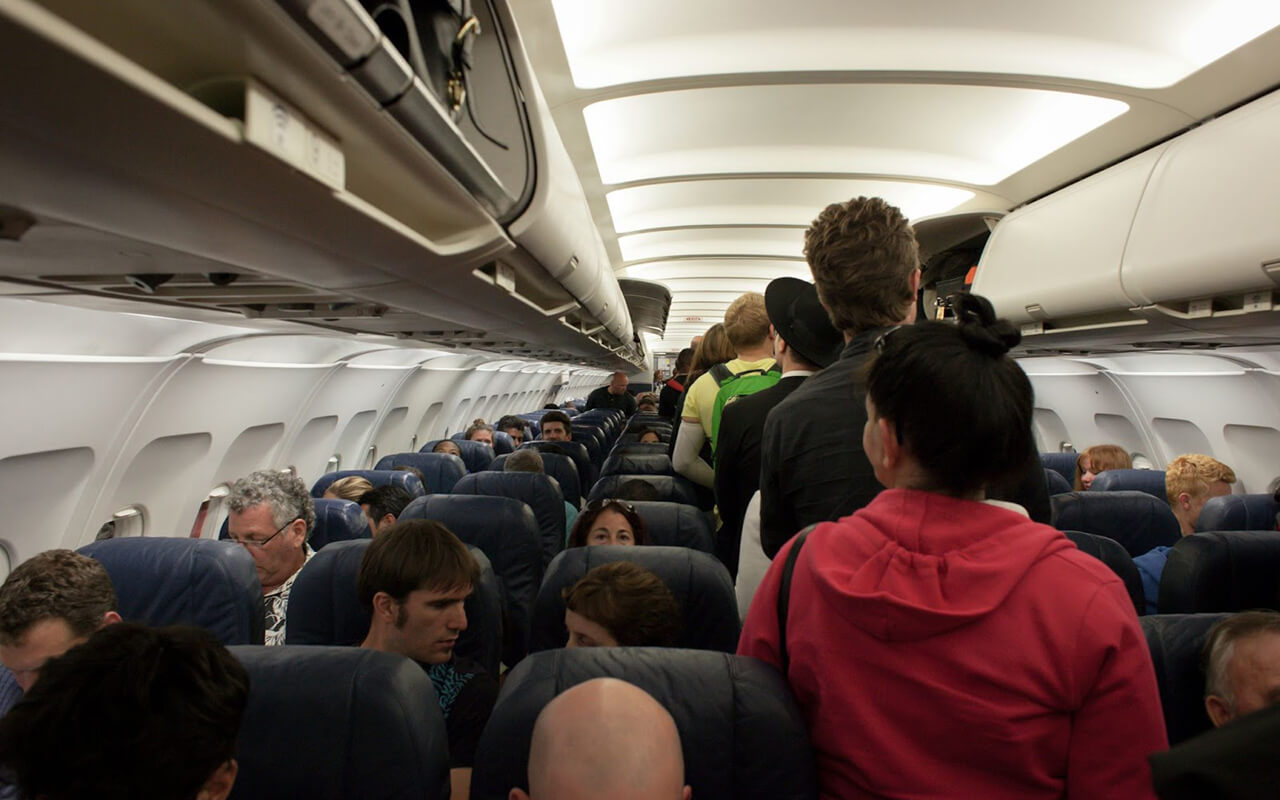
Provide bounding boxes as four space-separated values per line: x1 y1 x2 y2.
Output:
230 646 449 800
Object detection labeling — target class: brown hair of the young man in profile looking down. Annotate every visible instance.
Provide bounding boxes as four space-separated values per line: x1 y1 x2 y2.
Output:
356 520 480 609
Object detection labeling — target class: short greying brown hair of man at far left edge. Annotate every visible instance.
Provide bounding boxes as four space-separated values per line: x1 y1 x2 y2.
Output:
0 550 116 644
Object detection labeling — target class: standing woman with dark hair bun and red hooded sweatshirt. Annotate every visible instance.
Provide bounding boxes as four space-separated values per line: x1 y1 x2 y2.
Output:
739 294 1167 799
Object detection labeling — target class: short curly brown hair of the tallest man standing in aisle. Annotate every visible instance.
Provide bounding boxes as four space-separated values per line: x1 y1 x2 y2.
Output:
804 197 920 333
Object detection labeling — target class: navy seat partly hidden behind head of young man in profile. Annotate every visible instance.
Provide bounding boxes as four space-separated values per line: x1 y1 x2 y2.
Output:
284 540 502 675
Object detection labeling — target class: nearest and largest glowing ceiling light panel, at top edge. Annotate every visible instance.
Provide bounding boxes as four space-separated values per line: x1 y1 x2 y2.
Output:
552 0 1280 88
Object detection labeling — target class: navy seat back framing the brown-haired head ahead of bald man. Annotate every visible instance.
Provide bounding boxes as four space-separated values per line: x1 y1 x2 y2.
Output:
529 545 739 653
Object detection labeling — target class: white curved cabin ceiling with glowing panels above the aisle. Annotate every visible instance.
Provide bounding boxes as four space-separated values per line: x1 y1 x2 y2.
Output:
513 0 1280 352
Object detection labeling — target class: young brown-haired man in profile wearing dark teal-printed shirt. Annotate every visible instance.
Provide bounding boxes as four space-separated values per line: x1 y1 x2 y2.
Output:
356 520 498 800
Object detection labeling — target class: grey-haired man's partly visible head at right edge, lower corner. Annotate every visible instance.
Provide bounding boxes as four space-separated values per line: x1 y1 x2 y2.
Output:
1201 611 1280 727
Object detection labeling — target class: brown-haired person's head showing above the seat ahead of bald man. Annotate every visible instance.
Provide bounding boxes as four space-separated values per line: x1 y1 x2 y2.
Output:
564 561 681 648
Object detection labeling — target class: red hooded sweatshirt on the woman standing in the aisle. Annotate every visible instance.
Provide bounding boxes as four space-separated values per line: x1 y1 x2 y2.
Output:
739 489 1169 800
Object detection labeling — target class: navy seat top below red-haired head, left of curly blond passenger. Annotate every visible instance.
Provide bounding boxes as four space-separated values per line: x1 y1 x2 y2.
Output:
1048 492 1181 558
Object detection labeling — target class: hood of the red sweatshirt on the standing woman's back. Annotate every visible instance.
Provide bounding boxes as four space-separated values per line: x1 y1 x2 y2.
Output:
801 489 1075 641
